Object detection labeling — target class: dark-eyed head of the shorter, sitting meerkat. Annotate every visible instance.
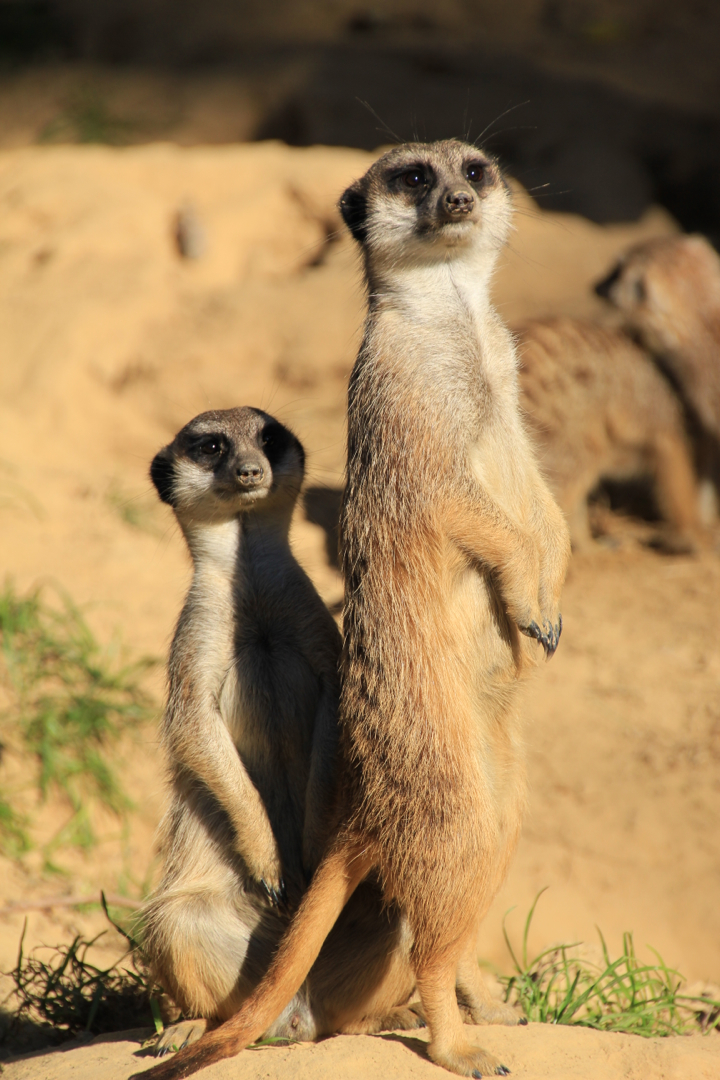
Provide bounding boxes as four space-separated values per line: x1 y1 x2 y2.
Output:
150 407 304 522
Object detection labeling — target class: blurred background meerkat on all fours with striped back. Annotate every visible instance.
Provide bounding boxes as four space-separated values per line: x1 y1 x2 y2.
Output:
517 318 701 551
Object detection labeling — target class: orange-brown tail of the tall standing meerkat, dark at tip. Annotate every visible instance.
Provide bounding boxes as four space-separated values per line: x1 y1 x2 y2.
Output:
130 843 371 1080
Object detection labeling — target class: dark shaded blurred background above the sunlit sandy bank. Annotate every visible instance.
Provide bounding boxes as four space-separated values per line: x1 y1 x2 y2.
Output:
0 0 720 235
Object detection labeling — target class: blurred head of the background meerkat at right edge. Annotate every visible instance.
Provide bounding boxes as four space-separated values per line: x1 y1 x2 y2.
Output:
595 235 720 354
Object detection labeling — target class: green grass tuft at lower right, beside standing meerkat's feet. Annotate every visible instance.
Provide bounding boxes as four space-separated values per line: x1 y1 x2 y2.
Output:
500 890 720 1038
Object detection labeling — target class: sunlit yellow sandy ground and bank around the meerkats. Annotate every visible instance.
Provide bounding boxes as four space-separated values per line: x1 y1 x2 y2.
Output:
0 144 720 1080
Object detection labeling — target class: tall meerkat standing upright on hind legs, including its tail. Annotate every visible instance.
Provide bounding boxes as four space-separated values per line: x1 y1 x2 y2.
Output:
134 140 570 1080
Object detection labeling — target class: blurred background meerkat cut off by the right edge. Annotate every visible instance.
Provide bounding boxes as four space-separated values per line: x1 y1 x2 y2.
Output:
596 235 720 522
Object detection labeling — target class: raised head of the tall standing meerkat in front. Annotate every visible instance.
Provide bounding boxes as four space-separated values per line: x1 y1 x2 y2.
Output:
340 139 512 268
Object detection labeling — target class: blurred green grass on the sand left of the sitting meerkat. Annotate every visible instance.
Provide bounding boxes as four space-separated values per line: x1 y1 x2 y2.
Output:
0 583 154 855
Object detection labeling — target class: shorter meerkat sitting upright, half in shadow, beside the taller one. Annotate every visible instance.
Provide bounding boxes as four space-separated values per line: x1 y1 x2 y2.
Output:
144 408 427 1053
